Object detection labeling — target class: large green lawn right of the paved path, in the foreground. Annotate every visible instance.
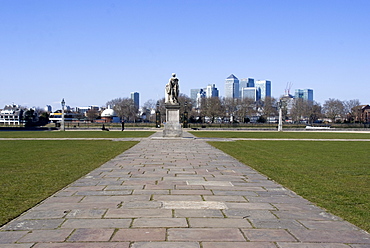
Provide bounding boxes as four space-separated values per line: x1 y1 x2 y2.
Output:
209 141 370 231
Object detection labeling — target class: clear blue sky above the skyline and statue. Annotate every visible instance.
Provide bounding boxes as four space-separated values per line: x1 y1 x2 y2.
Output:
0 0 370 110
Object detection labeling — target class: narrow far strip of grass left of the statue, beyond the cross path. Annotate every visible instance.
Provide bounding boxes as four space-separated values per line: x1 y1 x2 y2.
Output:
0 131 154 138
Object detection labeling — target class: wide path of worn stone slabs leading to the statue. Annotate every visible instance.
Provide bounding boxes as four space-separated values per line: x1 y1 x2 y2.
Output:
0 133 370 248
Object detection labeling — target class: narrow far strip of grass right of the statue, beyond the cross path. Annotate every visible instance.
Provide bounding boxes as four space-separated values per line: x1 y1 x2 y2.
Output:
189 131 370 139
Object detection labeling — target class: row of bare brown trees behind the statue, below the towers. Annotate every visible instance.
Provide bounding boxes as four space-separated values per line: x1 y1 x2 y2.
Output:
107 94 361 123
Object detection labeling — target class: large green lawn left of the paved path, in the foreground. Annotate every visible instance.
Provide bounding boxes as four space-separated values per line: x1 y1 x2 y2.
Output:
0 140 137 226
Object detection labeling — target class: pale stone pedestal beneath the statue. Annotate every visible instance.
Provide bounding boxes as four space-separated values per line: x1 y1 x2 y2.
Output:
163 104 182 137
